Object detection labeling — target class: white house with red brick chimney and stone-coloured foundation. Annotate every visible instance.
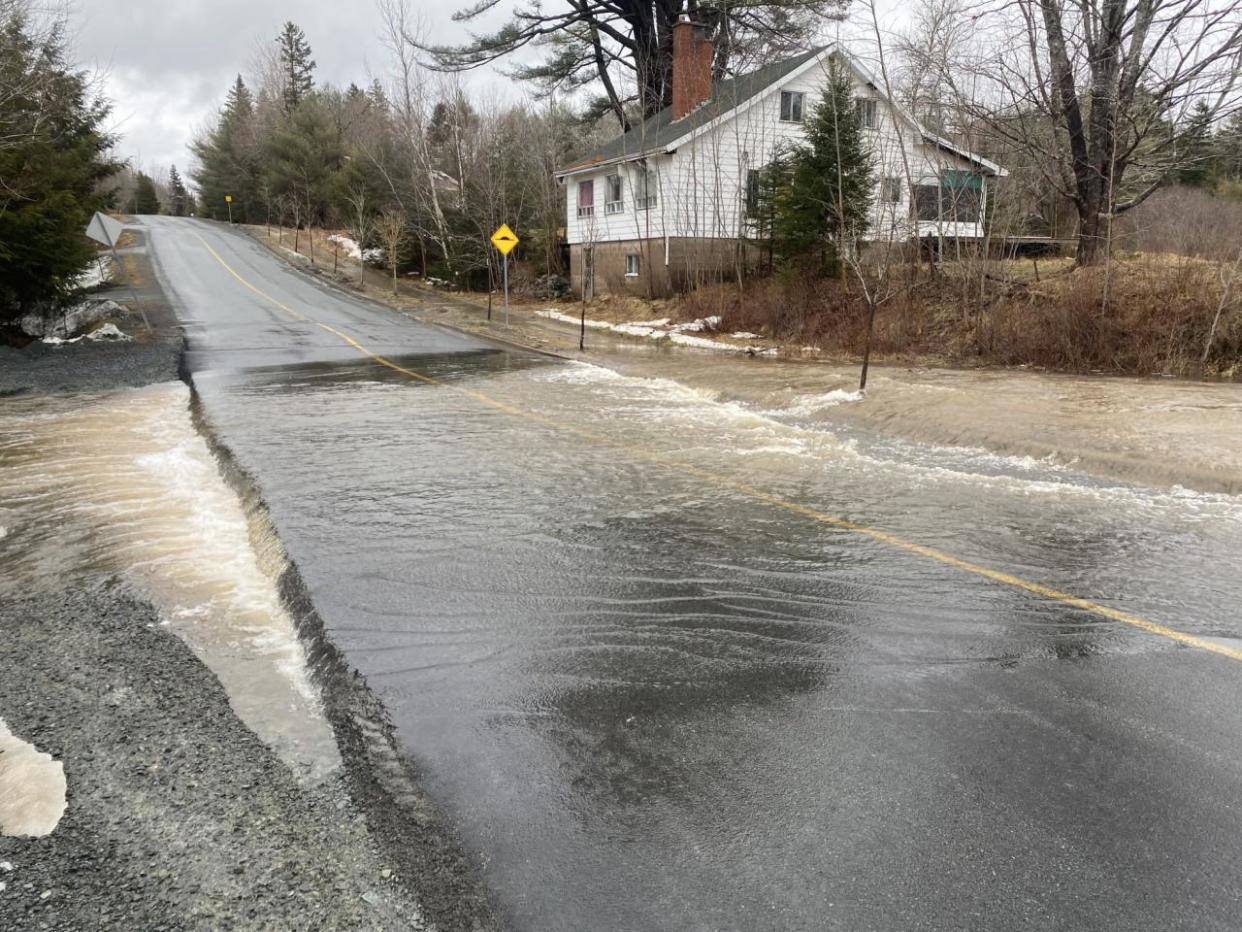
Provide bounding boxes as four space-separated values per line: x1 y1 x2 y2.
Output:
558 15 1005 295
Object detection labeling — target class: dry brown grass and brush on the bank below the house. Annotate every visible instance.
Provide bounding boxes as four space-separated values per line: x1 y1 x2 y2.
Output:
682 255 1242 378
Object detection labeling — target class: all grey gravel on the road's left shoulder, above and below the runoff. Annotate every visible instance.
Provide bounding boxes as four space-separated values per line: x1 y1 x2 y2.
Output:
0 234 498 932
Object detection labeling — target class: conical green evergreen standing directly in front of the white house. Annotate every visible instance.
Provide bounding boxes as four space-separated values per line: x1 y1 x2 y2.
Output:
774 58 873 271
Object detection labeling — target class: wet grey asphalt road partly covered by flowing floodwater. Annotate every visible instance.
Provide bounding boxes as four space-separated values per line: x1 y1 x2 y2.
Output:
152 220 1242 932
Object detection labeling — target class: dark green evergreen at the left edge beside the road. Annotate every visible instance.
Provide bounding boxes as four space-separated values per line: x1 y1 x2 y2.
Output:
0 4 120 322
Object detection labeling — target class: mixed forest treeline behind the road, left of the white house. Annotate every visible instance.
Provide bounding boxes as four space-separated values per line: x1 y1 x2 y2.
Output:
191 22 584 283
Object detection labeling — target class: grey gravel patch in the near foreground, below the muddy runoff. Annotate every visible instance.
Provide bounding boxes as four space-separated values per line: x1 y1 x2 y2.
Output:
0 584 425 930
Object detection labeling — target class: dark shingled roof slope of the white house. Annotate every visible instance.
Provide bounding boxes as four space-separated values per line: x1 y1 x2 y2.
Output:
559 46 828 174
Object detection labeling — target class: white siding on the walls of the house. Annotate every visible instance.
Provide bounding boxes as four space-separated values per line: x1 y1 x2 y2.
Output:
565 49 982 244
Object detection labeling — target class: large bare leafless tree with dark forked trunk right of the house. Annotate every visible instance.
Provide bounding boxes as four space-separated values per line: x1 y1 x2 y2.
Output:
943 0 1242 265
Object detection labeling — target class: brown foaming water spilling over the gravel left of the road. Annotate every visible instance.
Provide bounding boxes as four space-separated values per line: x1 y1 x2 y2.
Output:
0 383 340 782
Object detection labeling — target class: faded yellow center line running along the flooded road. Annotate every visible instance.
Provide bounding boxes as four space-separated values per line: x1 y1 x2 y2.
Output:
195 234 1242 661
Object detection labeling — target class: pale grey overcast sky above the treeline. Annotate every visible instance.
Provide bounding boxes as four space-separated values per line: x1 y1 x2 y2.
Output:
73 0 900 182
